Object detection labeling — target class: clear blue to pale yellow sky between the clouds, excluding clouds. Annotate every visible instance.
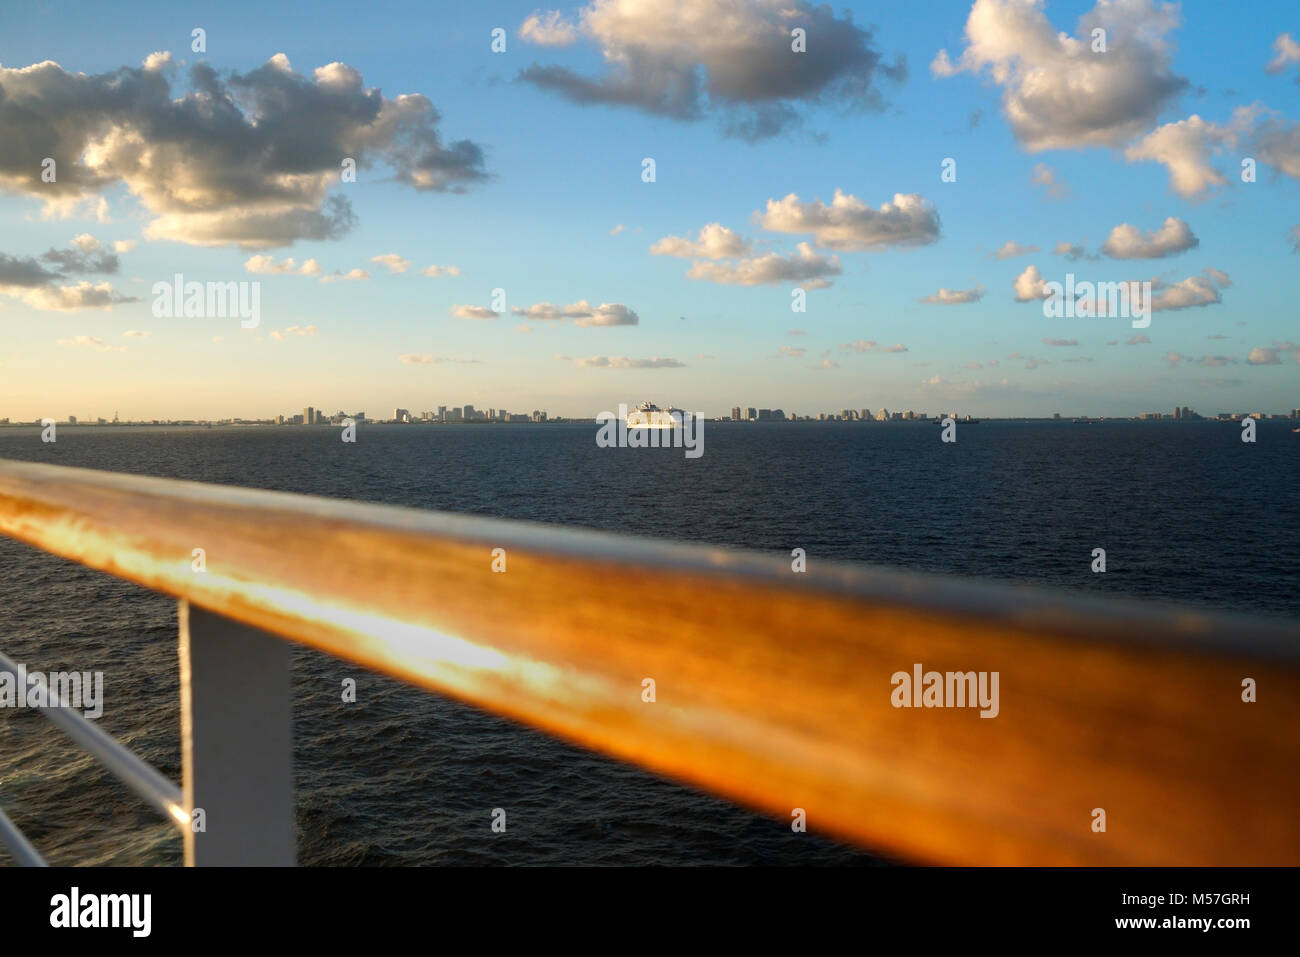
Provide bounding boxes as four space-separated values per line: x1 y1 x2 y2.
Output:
0 0 1300 419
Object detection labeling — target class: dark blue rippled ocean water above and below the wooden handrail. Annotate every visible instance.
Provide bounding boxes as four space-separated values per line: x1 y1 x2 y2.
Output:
0 421 1300 865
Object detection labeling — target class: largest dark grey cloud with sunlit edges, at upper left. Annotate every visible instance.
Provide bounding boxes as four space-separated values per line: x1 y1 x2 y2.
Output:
0 53 486 247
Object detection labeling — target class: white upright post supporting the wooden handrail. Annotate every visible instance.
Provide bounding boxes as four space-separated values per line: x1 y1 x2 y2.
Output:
181 601 295 867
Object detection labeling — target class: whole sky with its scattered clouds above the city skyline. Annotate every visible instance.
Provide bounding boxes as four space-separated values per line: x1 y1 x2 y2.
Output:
0 0 1300 420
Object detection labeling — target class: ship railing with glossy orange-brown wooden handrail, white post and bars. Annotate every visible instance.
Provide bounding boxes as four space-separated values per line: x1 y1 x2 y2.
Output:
0 460 1300 865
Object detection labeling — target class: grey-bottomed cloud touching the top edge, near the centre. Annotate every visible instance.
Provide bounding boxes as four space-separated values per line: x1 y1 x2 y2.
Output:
519 0 906 140
